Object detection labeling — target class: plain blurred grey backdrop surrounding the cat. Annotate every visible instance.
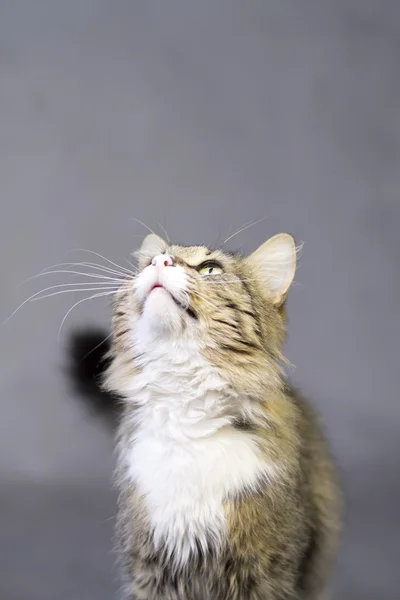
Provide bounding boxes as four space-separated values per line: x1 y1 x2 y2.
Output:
0 0 400 600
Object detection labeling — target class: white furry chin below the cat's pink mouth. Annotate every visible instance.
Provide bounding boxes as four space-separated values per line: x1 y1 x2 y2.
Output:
141 287 182 333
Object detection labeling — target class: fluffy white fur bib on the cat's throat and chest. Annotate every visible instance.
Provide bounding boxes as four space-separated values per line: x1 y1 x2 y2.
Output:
119 336 275 563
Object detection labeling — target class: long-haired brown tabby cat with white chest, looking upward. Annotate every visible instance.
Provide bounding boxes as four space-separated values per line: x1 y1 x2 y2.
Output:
68 234 342 600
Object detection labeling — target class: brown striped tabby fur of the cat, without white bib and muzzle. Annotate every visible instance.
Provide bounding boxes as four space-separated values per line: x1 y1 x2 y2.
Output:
102 239 341 600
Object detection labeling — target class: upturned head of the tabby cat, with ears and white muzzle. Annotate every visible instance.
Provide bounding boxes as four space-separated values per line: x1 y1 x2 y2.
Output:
108 233 296 394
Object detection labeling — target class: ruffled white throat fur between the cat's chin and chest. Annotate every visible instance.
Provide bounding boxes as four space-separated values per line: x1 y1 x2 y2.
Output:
128 338 237 440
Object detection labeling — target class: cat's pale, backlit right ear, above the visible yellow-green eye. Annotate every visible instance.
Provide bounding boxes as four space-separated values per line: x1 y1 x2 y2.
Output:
249 233 297 306
